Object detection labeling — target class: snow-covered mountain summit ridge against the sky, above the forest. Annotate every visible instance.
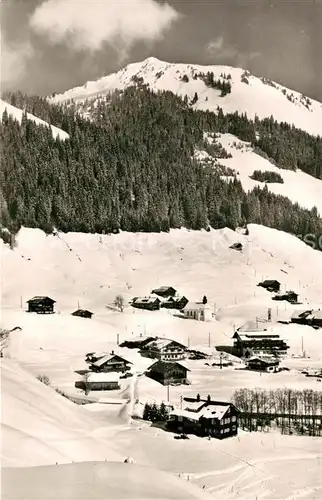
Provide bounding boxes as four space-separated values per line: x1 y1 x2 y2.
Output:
50 57 322 135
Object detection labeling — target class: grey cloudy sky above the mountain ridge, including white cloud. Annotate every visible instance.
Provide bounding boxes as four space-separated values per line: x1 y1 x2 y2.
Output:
1 0 322 101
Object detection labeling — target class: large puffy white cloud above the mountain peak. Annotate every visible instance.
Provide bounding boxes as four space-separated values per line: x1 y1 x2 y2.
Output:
30 0 179 57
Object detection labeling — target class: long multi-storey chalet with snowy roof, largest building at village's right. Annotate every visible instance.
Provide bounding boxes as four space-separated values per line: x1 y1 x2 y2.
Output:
233 330 289 358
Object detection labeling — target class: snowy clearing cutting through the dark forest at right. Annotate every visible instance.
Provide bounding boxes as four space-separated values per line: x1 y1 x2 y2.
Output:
200 134 322 216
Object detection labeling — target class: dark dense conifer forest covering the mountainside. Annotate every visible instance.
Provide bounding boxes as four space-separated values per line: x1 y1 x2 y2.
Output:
0 86 322 249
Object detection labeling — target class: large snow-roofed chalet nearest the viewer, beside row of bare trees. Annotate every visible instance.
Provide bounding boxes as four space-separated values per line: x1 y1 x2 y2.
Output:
167 396 239 439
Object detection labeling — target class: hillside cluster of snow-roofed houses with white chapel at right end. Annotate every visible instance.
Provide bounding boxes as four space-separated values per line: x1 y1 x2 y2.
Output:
130 286 212 321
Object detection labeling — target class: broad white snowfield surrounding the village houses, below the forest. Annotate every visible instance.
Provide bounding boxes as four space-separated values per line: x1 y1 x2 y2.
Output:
1 224 322 500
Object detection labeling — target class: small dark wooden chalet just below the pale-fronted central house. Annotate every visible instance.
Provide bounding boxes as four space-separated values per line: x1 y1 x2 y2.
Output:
146 360 190 385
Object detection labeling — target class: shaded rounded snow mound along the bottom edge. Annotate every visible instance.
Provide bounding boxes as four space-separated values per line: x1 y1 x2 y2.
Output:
2 462 212 500
